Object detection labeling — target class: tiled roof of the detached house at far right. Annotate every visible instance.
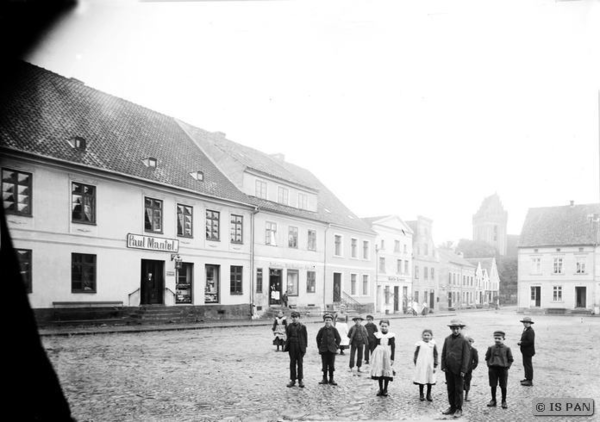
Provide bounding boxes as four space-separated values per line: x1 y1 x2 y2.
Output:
519 204 600 247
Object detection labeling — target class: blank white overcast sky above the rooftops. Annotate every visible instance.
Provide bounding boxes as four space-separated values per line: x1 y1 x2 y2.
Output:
26 0 600 244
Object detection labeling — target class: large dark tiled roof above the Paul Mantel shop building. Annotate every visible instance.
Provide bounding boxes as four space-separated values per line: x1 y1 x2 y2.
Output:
0 62 248 203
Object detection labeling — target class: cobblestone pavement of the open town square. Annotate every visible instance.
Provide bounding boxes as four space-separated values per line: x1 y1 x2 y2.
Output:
42 310 600 422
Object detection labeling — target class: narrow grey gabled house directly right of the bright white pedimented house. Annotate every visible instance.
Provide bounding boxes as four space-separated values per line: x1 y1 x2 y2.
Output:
406 216 442 310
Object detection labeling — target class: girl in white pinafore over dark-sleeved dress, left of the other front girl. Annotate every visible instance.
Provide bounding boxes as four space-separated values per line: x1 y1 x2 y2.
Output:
371 319 396 397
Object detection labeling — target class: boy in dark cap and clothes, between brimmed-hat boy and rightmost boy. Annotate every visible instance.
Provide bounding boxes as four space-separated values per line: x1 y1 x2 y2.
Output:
485 331 513 409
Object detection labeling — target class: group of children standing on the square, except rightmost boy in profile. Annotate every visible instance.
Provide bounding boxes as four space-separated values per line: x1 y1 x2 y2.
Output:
273 311 533 417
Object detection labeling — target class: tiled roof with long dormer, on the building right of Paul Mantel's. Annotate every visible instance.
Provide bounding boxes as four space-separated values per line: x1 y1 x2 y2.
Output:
179 121 375 234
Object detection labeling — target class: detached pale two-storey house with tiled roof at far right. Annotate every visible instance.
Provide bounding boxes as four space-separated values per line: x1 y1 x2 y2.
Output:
518 202 600 312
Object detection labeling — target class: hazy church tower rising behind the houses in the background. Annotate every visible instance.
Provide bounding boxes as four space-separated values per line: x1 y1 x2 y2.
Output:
473 193 508 256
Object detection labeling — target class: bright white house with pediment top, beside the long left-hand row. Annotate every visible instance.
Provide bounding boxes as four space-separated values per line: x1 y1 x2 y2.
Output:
363 215 413 313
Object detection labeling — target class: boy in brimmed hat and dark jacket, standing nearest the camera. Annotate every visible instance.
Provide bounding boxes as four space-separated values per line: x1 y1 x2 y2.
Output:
441 319 471 418
